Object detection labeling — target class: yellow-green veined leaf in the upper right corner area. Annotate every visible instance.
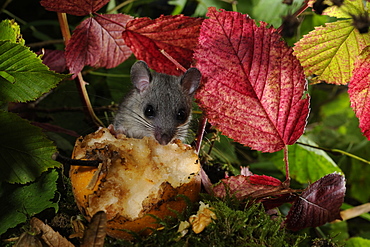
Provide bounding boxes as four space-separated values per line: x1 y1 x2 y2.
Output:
294 20 370 85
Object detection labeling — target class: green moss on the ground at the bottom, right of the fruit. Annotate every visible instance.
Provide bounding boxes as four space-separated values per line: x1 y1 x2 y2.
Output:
106 198 305 247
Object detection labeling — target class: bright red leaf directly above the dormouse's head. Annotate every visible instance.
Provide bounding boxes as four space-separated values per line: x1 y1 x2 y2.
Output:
123 15 203 75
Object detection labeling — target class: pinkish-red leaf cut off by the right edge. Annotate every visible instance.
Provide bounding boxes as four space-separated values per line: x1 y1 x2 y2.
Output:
348 47 370 140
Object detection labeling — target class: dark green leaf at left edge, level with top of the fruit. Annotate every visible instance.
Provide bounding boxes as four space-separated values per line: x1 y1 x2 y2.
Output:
0 112 60 184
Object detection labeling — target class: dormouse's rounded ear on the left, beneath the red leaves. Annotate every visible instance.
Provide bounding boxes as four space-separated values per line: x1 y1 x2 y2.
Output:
130 61 152 93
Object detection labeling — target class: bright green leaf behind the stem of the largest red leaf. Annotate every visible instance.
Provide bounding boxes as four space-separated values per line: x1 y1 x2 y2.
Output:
271 136 343 184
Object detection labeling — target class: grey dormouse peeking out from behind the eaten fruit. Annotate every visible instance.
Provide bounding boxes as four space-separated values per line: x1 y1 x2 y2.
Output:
113 61 201 145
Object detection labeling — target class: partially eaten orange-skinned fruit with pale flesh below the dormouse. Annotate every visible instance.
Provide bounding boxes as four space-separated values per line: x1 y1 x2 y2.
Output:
70 128 201 239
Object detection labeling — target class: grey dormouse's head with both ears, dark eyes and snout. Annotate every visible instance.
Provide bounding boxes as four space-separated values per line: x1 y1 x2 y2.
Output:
131 61 201 145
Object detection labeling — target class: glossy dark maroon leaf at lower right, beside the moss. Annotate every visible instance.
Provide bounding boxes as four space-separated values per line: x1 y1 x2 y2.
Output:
284 173 346 231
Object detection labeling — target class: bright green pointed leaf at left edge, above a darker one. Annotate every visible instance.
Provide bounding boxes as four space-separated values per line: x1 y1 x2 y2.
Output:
0 41 68 102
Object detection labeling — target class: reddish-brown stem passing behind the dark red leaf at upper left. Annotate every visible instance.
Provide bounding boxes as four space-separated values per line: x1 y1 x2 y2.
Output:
57 13 104 127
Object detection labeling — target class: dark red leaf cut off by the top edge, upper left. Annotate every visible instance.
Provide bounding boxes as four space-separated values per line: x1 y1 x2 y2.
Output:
40 0 109 16
